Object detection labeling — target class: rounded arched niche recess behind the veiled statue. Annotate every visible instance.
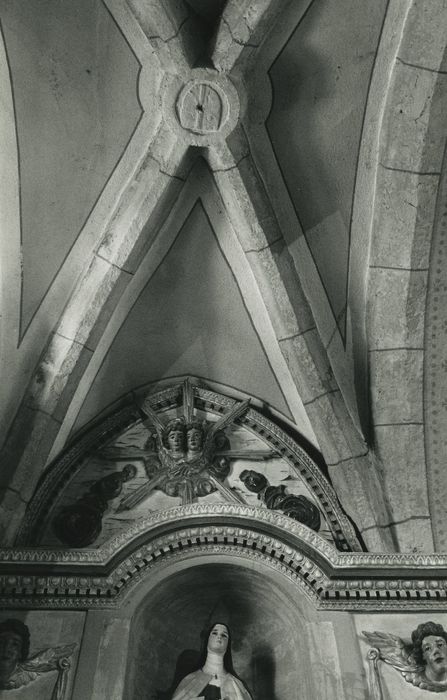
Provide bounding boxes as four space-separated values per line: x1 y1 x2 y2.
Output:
124 556 322 700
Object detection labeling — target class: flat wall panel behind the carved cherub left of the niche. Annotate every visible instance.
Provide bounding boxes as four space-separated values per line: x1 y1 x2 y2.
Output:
0 610 87 700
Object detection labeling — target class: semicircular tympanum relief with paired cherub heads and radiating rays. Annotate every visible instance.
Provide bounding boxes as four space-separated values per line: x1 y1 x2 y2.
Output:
32 380 340 547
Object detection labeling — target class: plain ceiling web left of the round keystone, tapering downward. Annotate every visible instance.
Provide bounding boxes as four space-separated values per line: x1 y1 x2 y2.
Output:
2 0 141 336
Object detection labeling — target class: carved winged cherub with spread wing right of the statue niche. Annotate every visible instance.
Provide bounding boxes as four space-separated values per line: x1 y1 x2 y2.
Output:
363 622 447 699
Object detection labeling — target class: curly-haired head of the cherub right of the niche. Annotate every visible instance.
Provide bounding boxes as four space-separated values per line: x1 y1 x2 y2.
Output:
411 622 447 683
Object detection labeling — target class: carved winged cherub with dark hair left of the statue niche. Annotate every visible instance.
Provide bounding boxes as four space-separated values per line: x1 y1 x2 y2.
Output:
0 618 76 700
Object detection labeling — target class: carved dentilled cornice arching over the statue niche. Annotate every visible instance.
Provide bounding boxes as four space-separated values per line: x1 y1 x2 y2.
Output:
0 504 447 611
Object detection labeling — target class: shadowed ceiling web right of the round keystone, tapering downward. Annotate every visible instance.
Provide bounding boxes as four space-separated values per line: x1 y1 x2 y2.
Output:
267 0 387 336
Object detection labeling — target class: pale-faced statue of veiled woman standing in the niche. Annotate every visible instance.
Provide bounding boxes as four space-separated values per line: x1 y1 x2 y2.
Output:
172 622 252 700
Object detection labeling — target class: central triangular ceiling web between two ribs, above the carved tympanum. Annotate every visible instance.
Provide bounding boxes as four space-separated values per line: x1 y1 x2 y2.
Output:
75 201 290 429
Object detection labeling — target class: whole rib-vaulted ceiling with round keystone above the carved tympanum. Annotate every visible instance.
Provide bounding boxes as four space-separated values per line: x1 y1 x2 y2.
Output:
0 0 447 552
